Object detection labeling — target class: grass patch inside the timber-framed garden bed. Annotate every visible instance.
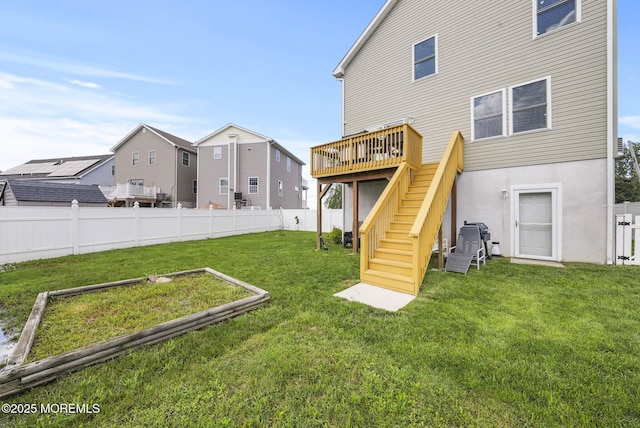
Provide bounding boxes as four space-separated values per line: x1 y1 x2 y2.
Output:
27 274 251 362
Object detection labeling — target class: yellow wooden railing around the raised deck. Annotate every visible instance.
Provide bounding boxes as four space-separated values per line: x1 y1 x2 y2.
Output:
311 123 422 178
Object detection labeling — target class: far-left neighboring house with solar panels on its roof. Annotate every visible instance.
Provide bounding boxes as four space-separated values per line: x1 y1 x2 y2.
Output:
0 154 115 186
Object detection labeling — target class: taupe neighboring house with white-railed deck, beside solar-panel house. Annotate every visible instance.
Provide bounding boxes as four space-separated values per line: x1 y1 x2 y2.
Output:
105 124 197 208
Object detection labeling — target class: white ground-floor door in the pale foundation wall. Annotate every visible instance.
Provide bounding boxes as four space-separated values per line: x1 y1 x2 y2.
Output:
513 187 561 260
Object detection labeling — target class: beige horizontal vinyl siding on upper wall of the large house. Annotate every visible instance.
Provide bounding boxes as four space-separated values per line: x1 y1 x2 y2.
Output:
342 0 607 171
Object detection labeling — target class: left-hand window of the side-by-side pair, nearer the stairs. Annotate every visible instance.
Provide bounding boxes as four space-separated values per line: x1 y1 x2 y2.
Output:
471 89 506 140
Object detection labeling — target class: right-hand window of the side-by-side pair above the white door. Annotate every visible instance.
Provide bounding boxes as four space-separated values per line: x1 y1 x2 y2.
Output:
509 77 551 134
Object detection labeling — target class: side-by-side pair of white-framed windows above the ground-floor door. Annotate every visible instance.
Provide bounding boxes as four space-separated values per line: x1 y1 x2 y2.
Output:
471 77 551 140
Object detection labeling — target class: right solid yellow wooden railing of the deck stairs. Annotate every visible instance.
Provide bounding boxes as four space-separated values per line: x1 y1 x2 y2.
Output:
409 131 464 294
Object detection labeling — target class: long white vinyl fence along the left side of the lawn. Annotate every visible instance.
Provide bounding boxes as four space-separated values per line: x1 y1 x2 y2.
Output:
0 204 342 266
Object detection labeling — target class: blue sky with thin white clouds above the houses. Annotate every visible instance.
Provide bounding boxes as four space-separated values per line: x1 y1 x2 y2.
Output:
0 0 640 186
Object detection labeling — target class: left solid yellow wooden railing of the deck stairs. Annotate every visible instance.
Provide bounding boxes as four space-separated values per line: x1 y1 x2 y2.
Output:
360 162 412 274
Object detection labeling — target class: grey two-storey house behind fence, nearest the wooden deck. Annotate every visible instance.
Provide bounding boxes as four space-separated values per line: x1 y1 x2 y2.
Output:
195 123 307 209
